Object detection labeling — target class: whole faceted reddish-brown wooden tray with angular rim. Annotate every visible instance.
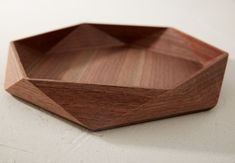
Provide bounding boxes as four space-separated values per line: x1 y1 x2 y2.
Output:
5 24 228 130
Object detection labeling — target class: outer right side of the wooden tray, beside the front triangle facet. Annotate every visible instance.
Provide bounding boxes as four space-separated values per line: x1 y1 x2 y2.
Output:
117 56 227 123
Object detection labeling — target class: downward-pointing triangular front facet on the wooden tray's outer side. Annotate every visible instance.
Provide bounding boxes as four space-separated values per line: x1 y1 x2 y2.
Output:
31 80 165 130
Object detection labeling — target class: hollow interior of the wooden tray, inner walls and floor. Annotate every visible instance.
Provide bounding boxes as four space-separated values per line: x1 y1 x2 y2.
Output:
13 24 222 89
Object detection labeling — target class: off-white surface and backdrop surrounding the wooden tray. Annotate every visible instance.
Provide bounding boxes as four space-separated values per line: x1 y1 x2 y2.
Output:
0 0 235 163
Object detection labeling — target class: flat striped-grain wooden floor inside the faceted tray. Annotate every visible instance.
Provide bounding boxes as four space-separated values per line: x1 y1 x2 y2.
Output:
29 46 202 89
